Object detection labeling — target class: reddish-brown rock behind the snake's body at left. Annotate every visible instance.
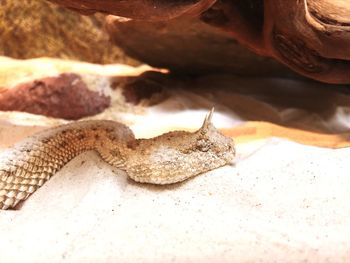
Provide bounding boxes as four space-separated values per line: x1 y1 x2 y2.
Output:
0 74 110 120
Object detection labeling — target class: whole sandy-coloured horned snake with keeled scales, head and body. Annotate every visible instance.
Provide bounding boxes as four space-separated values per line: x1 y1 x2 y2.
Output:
0 109 236 210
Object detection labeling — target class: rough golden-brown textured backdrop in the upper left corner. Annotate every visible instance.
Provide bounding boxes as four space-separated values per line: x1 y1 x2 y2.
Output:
0 0 138 65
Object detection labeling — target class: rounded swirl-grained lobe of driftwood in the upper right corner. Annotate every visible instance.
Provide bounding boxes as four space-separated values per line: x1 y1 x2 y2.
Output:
264 0 350 83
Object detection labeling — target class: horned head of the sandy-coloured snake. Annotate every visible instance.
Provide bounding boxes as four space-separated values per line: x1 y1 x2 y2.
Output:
126 109 235 184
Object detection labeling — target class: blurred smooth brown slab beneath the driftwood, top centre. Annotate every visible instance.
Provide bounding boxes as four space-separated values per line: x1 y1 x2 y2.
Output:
107 16 296 77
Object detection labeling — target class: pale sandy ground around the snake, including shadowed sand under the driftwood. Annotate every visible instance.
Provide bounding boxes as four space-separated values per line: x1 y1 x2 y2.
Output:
0 69 350 262
